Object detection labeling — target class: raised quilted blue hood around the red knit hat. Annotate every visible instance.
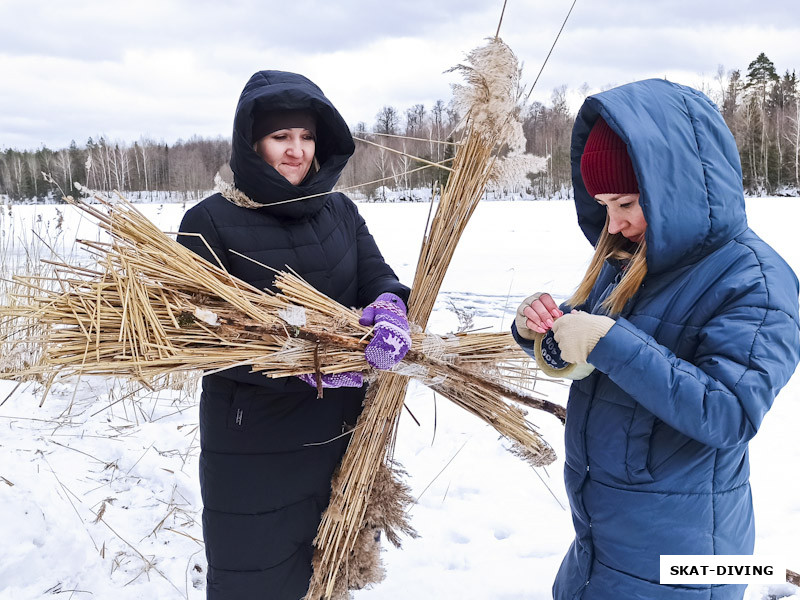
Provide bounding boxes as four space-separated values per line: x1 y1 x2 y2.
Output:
571 79 747 273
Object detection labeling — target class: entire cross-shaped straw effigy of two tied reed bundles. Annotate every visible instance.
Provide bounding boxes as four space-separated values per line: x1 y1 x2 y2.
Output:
0 38 564 598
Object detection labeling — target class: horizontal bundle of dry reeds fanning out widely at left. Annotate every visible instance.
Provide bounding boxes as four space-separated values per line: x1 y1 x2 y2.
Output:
0 192 562 422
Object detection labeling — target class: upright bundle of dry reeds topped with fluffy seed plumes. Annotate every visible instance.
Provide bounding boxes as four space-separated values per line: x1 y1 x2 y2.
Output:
306 37 543 599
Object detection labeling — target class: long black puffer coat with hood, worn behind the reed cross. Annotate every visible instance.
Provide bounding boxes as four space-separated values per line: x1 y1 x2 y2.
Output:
178 71 408 600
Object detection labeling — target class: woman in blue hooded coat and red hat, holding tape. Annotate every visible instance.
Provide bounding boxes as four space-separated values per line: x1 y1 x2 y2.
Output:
513 80 800 600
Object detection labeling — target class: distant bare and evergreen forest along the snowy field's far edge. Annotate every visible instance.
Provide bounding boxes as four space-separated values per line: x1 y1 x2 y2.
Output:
0 53 800 201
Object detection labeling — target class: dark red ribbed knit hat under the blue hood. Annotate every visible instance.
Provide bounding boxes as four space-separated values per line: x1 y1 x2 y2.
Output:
581 117 639 198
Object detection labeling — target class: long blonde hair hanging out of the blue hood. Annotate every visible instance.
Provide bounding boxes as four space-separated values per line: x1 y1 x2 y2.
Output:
567 216 647 315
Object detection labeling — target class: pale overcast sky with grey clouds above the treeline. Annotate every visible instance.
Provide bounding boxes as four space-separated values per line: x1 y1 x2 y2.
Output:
0 0 800 149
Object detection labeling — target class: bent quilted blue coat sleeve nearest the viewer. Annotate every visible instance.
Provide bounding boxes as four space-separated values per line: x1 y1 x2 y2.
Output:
588 304 800 448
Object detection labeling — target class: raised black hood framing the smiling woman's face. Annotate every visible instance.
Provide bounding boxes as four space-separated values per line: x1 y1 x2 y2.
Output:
230 71 355 218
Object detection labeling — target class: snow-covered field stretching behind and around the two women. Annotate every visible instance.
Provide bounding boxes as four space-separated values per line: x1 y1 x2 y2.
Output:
0 198 800 600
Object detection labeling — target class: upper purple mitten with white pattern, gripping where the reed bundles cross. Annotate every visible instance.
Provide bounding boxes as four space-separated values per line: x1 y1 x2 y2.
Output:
358 292 411 371
